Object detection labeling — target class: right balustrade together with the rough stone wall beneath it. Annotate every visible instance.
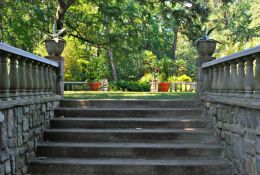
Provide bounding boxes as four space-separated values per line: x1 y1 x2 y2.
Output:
199 46 260 175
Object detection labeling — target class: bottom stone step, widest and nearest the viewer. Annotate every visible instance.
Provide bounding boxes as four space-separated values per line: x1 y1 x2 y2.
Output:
30 158 231 175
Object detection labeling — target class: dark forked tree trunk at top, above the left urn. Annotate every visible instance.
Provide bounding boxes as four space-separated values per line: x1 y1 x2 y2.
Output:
56 0 76 30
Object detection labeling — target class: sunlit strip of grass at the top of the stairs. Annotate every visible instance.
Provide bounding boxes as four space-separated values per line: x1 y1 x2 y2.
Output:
64 91 195 99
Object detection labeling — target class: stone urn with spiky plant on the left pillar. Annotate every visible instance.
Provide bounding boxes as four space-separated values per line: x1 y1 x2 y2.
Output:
44 22 66 56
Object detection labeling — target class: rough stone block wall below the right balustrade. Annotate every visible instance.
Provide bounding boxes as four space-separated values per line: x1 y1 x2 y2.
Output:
205 98 260 175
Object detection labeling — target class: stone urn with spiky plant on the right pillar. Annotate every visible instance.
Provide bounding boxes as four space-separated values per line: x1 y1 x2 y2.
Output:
195 27 221 57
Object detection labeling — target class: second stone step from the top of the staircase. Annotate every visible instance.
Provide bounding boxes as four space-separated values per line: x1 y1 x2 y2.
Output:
55 108 202 118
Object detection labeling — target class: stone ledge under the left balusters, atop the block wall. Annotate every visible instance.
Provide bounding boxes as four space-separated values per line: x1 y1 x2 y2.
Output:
0 95 61 109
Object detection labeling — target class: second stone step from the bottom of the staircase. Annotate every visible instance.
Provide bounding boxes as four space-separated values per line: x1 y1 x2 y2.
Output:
37 142 222 159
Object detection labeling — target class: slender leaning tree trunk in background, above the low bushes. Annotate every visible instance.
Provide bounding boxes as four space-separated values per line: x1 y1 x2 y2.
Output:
105 15 117 81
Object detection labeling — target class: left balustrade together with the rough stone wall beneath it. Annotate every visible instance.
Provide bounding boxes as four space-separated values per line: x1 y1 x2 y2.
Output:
0 42 63 175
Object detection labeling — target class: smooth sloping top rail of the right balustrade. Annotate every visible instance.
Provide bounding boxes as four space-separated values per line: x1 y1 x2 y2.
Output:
202 45 260 68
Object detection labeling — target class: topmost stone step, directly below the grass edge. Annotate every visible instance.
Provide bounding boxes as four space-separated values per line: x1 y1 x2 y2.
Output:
61 99 199 108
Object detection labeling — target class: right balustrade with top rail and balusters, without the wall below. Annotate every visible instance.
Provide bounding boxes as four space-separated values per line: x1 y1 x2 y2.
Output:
202 46 260 98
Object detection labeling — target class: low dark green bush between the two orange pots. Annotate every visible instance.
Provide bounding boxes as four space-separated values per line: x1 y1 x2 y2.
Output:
109 80 150 92
